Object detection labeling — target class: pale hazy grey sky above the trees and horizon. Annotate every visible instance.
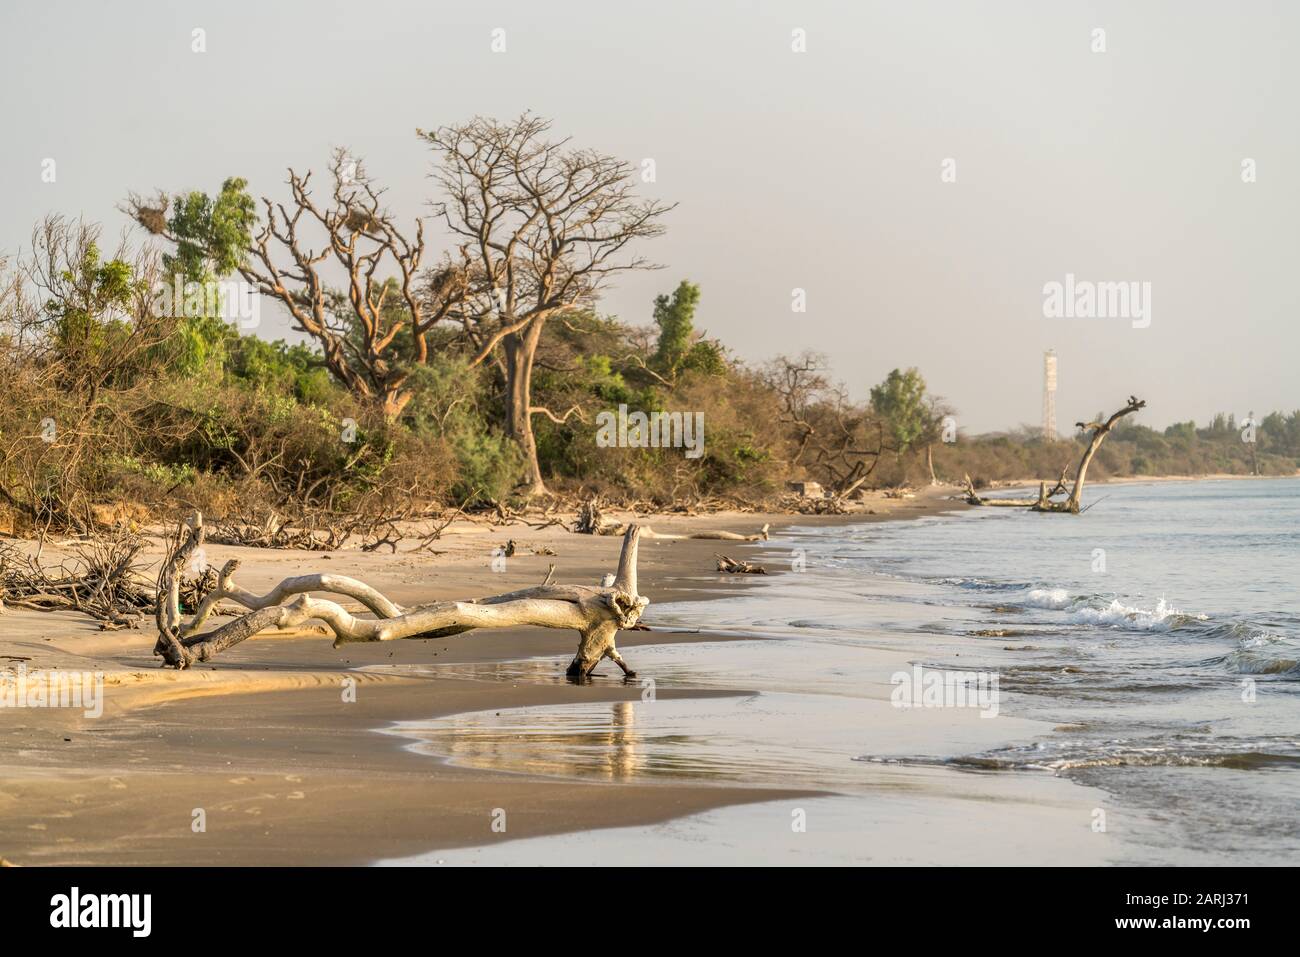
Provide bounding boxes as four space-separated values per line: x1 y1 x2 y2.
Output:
0 0 1300 432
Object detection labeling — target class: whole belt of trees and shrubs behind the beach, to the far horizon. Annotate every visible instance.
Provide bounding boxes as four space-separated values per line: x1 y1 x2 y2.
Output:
0 114 1300 545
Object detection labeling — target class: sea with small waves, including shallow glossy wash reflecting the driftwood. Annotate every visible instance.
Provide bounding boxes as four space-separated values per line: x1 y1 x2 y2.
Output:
379 480 1300 863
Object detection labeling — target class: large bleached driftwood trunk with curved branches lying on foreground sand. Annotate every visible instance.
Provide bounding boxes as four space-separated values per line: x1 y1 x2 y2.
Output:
153 515 650 679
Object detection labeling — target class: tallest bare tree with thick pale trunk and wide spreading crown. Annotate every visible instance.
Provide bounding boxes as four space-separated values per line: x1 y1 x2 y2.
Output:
419 113 673 494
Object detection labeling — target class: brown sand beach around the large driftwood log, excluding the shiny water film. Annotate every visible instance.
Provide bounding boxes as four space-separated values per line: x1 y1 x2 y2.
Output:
0 490 1107 865
